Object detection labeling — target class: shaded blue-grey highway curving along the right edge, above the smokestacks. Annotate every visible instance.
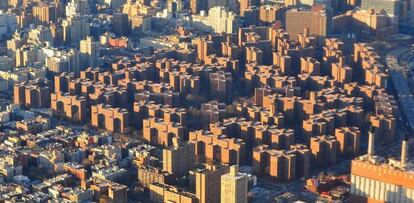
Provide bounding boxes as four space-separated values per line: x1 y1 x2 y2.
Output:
386 48 414 130
